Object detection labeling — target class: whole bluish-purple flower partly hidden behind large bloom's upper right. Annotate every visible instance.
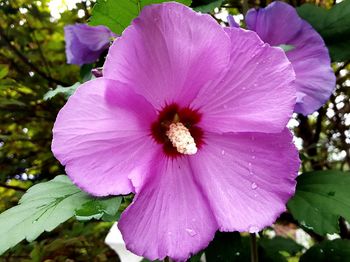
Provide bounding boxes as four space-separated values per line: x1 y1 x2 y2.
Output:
246 1 335 115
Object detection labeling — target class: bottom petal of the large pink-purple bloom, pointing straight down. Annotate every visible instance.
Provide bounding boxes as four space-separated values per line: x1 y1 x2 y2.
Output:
118 152 217 261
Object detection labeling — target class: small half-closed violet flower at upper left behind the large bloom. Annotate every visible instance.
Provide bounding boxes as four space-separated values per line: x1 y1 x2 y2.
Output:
64 24 116 65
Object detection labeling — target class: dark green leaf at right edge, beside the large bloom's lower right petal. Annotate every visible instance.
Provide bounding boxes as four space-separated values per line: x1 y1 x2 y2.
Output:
288 171 350 235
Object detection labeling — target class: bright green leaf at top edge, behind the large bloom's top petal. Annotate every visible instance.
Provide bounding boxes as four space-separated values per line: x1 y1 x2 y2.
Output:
89 0 191 35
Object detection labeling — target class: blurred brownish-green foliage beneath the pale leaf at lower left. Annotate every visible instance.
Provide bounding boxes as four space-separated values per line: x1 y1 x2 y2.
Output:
0 220 119 262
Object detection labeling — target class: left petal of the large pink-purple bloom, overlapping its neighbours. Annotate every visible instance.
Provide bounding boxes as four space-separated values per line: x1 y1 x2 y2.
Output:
52 78 158 196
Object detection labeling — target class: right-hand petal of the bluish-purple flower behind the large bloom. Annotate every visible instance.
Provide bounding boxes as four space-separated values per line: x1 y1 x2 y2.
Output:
287 21 336 115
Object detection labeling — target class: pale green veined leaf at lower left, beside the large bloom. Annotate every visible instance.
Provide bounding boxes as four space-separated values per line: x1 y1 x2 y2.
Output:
0 175 91 254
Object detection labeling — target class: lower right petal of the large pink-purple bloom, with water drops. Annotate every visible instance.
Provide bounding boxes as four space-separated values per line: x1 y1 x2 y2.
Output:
190 130 300 232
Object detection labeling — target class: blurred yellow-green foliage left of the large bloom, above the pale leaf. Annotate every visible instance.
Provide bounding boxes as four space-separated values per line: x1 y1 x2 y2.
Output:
0 0 79 184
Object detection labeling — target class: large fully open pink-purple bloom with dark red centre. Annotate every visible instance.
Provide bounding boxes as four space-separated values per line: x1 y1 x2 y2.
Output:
52 3 299 260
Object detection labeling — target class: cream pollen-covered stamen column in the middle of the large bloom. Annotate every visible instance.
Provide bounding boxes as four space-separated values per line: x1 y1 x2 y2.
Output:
166 122 198 155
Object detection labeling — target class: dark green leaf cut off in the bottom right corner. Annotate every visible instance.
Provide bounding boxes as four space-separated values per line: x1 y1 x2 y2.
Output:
300 239 350 262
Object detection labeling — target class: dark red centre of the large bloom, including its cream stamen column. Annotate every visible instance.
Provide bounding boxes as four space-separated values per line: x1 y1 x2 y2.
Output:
151 103 203 157
